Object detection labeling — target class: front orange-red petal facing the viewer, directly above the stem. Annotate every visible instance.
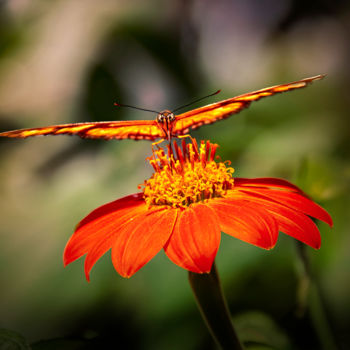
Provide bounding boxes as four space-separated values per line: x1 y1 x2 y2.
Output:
164 203 221 273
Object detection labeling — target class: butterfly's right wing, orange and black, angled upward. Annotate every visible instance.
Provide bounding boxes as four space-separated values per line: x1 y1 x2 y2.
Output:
172 75 324 136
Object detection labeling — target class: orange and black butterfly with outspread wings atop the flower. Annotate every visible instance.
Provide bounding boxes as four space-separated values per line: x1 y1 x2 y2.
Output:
0 75 325 143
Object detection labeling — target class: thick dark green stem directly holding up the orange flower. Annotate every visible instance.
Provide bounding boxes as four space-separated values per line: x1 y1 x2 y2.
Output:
188 262 243 350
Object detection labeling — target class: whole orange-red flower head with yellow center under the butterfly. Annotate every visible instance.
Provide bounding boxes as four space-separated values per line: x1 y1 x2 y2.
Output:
64 139 332 280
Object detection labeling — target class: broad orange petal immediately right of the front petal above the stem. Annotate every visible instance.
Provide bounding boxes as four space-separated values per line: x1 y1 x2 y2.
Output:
208 198 278 249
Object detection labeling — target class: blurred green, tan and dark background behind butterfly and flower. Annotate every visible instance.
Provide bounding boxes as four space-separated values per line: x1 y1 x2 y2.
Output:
0 0 350 350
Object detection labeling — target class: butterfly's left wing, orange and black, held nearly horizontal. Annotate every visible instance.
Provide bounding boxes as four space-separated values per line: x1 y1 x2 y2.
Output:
0 120 164 141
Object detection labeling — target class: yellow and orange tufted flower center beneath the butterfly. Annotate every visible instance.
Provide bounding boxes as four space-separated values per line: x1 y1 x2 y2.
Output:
143 139 234 208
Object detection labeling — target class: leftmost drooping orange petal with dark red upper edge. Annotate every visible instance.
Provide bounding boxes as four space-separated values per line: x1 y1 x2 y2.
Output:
63 194 146 276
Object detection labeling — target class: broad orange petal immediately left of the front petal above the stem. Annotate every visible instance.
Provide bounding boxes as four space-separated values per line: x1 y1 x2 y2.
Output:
112 207 177 277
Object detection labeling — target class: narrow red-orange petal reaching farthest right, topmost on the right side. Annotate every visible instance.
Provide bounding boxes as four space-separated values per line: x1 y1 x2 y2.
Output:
238 188 333 226
